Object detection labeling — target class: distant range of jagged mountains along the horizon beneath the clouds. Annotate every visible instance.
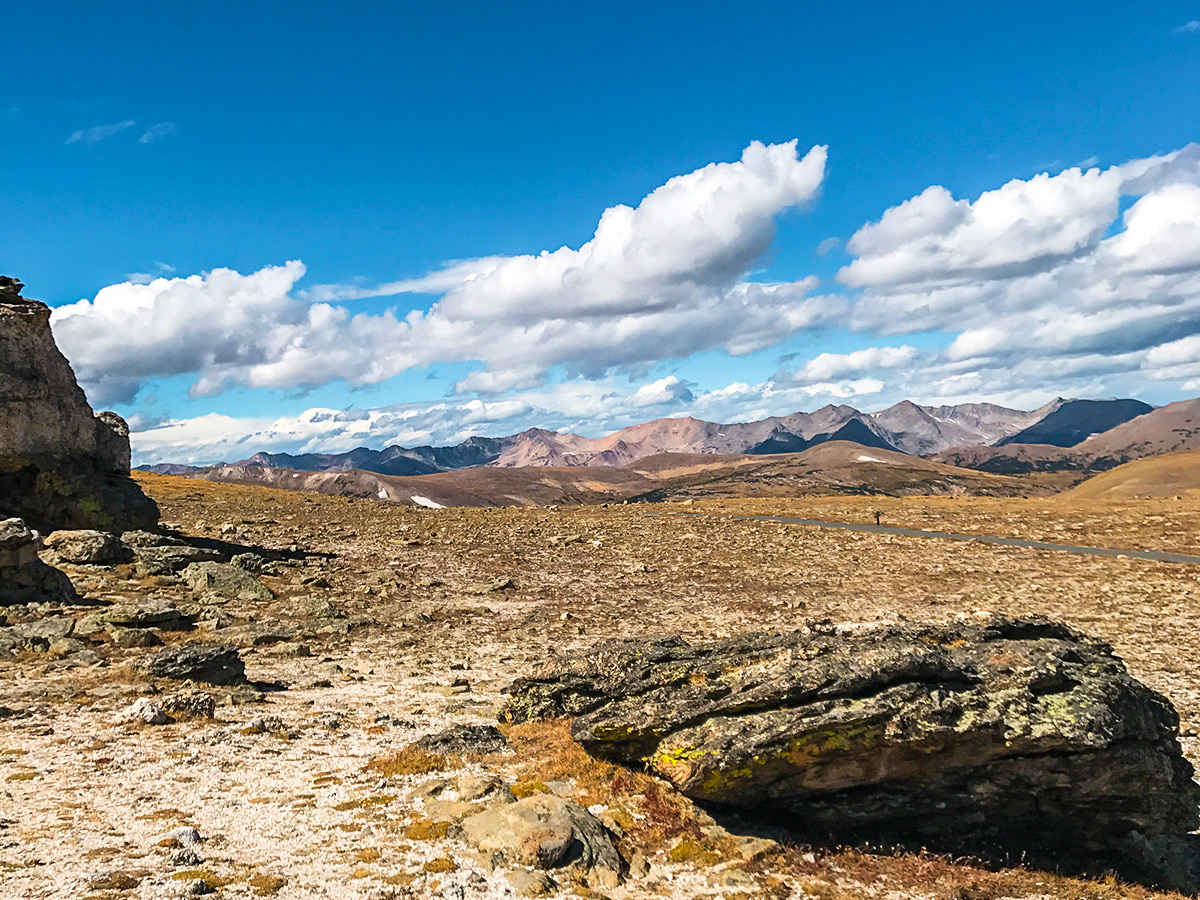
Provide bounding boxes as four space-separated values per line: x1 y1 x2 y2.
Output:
140 398 1200 476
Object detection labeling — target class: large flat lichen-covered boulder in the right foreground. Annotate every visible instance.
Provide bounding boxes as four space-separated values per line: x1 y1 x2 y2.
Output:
505 619 1200 887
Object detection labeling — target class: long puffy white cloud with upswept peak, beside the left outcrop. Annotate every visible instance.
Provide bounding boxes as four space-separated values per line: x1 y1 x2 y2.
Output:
54 142 846 402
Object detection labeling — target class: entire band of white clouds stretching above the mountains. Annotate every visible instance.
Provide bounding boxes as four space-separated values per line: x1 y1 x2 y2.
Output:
44 138 1200 458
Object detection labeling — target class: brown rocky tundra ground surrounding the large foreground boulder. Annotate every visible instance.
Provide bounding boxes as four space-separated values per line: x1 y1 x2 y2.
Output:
0 476 1200 900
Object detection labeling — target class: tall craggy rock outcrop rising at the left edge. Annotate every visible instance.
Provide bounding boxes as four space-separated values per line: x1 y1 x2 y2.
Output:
0 277 158 533
